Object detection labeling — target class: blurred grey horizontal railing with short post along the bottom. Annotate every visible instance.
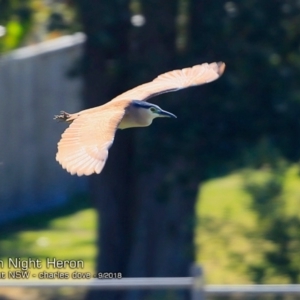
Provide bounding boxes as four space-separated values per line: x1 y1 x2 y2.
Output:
0 266 300 300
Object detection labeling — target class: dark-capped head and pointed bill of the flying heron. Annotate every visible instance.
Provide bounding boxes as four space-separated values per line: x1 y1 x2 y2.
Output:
132 100 177 122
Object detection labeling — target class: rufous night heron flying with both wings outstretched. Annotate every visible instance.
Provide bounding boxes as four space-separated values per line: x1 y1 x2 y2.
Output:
54 62 225 176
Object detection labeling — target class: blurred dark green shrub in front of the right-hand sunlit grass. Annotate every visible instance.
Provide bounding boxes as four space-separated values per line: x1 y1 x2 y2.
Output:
244 145 300 283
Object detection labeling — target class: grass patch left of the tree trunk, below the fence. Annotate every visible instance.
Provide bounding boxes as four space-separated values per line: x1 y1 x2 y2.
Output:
0 198 96 279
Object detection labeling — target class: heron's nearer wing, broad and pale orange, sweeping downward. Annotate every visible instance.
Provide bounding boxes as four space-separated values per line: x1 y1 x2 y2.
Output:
56 106 125 176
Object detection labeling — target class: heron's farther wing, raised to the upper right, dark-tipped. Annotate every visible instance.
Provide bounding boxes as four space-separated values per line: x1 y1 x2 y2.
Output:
112 62 225 101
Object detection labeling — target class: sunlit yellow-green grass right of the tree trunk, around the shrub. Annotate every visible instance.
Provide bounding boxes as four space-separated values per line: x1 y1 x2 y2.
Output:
195 166 300 284
